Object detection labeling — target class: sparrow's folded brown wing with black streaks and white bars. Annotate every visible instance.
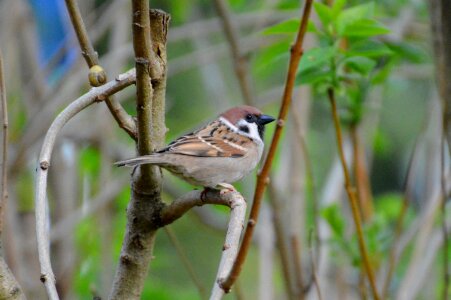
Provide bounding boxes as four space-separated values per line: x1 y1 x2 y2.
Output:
158 121 252 157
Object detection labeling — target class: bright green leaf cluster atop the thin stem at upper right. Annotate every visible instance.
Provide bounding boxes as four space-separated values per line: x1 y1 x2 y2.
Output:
257 0 403 124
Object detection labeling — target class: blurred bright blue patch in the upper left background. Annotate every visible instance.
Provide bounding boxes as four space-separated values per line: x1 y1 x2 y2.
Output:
28 0 78 84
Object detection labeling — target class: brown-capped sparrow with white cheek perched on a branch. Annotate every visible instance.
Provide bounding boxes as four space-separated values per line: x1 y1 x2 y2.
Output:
115 106 275 190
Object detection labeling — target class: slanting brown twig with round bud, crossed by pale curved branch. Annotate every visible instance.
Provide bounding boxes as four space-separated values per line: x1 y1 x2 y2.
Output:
66 0 137 140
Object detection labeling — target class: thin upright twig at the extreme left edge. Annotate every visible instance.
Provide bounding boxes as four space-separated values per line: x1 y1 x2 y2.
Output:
0 52 8 237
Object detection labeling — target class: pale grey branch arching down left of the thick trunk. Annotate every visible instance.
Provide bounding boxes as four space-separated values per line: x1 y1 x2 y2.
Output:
35 69 136 300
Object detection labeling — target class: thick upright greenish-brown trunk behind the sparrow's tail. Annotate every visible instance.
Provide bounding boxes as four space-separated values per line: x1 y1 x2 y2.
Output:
110 7 170 299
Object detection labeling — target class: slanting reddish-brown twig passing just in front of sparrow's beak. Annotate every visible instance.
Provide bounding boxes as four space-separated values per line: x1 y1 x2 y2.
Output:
221 0 313 292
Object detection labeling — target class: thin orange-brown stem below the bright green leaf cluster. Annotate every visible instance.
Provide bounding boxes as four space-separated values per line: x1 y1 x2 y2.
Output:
327 88 380 300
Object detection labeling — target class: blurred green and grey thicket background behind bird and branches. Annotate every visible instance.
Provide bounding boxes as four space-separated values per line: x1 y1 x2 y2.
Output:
0 0 451 299
